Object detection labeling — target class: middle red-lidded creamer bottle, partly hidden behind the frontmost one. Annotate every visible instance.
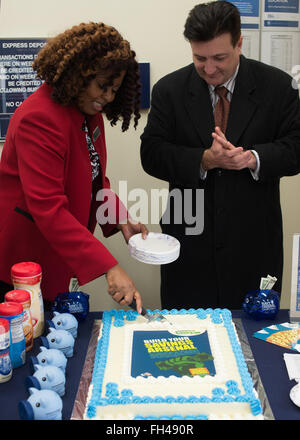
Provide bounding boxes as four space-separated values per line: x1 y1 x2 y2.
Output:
4 289 33 351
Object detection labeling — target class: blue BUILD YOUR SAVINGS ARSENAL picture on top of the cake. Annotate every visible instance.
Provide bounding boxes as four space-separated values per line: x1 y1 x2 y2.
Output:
131 330 216 377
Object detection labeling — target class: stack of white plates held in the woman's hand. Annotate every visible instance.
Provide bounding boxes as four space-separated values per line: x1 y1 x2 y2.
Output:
128 232 180 264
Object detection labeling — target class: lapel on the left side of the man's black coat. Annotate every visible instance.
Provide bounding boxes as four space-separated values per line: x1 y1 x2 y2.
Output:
184 66 214 148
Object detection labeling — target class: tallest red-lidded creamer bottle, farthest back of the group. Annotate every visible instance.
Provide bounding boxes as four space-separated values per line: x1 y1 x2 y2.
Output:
11 261 45 338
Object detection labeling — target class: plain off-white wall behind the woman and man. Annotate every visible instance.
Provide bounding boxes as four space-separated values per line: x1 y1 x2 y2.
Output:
0 0 300 310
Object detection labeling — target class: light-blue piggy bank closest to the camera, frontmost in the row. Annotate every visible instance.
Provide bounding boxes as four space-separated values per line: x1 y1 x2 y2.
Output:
18 388 63 420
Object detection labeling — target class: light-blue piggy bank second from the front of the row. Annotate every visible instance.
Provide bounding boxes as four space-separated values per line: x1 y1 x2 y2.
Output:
25 365 66 396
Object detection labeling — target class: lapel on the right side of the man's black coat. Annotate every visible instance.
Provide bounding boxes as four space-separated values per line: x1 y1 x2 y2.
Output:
226 56 259 145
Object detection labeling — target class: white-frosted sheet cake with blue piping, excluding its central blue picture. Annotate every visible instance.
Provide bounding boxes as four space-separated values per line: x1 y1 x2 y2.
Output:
85 312 262 420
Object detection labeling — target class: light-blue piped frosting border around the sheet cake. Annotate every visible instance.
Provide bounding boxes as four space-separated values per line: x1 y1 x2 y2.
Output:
87 308 262 420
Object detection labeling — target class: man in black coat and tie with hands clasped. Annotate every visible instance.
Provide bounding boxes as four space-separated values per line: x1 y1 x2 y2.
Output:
141 1 300 309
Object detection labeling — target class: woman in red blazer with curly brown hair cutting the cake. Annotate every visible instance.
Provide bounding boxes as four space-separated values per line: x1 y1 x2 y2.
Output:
0 23 147 309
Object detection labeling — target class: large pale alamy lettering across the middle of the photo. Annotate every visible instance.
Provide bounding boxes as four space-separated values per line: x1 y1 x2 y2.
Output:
96 180 204 235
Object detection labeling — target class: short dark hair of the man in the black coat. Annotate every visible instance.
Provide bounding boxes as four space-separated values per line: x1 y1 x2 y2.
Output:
183 1 241 47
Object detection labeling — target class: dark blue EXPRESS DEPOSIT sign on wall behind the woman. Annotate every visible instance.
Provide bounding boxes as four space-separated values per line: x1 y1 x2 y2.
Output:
0 39 46 140
